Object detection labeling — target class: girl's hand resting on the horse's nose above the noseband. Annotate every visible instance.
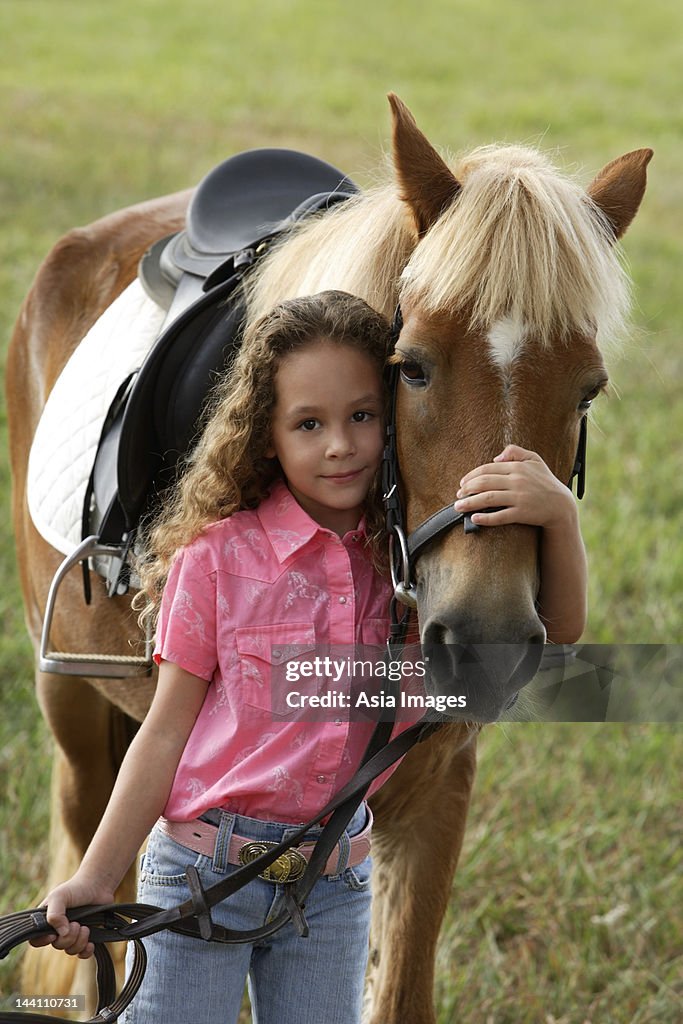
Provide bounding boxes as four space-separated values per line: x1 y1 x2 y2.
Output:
456 444 577 529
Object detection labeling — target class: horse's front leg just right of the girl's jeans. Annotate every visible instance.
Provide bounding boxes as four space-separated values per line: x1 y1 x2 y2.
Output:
366 725 476 1024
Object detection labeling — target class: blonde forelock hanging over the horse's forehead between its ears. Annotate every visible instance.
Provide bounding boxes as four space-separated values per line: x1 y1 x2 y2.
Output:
403 145 629 342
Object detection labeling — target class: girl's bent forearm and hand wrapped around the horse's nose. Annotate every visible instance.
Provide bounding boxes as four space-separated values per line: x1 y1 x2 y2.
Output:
456 444 588 643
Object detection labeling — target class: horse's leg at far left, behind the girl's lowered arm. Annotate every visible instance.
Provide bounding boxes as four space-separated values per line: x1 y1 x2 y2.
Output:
22 674 135 1010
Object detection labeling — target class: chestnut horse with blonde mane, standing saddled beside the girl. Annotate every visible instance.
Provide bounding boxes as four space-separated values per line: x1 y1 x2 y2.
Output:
7 96 651 1024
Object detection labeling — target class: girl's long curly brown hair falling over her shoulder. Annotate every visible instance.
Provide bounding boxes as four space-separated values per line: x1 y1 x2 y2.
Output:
134 291 391 622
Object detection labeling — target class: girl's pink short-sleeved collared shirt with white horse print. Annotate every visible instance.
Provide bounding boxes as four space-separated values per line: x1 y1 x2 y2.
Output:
155 482 401 822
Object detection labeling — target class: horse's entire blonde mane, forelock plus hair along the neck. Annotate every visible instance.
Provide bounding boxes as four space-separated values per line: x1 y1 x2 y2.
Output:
249 145 630 344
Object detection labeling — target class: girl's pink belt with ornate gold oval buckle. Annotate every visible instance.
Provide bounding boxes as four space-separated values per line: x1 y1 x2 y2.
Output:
157 808 373 884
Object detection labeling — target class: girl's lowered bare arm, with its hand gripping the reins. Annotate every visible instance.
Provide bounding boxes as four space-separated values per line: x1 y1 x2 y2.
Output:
34 662 208 957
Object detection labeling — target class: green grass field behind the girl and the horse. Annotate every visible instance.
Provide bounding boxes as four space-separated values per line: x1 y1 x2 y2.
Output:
0 0 683 1024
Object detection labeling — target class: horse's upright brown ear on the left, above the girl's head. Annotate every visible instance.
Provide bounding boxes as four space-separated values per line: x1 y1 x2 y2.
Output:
388 92 460 236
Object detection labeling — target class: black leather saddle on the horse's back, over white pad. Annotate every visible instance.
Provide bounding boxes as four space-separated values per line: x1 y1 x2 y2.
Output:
83 150 358 592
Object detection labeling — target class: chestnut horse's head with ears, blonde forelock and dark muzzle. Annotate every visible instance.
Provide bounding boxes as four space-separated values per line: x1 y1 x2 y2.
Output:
389 95 651 720
